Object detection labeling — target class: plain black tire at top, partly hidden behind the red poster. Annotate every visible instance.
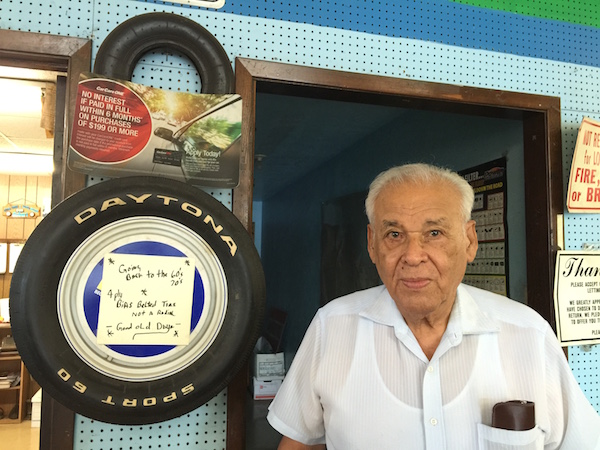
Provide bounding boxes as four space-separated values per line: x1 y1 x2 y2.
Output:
94 12 235 94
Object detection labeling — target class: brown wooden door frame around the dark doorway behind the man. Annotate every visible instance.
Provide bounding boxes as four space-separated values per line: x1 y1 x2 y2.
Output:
233 58 563 449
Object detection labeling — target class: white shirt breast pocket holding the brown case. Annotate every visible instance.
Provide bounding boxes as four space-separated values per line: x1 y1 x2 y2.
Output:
477 424 544 450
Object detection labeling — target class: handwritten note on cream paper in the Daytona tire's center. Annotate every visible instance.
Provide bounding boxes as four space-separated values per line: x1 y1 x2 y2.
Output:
97 253 195 345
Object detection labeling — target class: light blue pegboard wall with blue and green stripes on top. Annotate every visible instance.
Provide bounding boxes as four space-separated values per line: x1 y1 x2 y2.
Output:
0 0 600 444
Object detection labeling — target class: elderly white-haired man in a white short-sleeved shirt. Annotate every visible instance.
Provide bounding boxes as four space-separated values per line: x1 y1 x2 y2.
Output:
268 164 600 450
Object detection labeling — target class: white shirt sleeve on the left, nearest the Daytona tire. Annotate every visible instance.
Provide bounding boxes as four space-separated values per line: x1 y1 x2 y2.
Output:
267 313 325 445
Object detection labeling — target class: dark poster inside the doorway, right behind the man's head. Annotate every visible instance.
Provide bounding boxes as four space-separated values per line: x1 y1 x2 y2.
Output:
459 158 508 295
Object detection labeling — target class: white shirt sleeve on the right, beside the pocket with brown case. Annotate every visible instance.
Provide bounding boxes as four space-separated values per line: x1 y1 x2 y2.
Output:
544 327 600 450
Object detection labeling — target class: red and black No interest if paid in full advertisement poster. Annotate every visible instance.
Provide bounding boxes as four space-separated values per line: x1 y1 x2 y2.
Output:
68 73 242 188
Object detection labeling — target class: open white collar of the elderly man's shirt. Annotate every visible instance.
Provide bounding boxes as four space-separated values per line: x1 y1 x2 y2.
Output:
360 284 500 336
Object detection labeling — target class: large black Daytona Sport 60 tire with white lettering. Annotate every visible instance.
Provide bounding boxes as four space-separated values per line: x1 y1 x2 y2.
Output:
10 177 265 424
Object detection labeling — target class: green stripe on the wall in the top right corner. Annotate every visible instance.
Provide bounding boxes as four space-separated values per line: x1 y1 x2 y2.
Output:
451 0 600 28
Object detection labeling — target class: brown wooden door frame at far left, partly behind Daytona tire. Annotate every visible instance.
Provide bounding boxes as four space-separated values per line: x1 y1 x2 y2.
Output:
0 30 92 450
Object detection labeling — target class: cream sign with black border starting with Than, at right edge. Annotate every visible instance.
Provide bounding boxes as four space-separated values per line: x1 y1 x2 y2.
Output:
554 251 600 346
